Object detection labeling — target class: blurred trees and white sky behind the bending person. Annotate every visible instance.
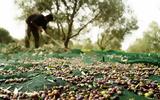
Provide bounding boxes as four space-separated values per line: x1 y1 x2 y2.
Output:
0 0 160 52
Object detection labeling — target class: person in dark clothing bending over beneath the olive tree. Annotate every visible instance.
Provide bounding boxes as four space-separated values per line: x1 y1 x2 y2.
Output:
25 14 53 48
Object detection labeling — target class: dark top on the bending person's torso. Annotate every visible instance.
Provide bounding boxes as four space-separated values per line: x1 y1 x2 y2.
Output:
26 14 48 30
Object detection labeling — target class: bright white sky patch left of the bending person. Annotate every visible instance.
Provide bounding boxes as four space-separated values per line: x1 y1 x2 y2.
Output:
0 0 25 39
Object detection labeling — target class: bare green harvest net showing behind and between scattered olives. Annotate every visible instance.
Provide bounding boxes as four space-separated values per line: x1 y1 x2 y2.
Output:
0 49 160 100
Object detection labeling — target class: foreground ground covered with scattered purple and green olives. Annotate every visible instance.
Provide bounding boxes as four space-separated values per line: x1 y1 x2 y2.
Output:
0 49 160 100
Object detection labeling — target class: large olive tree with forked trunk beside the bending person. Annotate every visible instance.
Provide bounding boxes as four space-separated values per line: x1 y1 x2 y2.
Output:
16 0 135 48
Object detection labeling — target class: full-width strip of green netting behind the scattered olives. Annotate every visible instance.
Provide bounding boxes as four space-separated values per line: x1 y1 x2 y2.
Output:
0 49 160 66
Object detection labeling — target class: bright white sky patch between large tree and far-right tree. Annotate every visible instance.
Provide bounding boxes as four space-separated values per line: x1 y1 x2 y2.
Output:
122 0 160 50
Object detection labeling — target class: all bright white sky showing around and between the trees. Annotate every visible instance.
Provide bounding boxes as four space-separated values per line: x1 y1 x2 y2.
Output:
0 0 160 50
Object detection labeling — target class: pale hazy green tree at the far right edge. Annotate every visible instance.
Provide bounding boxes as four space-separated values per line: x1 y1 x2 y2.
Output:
128 22 160 52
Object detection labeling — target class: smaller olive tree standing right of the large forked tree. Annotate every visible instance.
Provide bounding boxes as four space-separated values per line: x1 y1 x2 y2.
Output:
97 10 138 50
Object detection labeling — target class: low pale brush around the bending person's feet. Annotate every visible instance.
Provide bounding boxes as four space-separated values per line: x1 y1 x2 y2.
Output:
0 41 65 54
